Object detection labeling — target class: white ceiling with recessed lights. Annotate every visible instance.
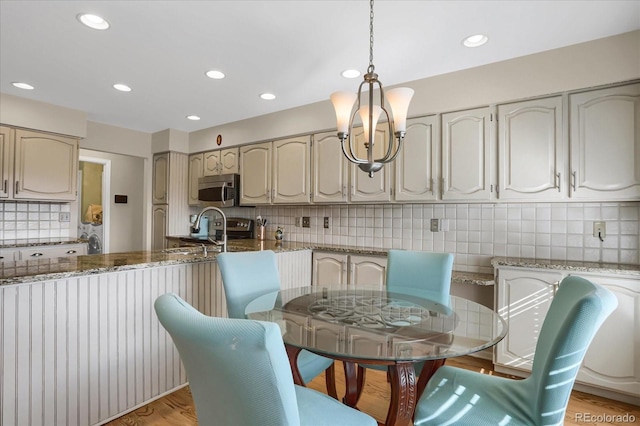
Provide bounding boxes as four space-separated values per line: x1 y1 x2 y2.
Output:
0 0 640 132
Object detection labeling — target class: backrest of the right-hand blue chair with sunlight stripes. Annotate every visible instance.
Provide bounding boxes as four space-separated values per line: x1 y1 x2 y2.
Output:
526 276 618 424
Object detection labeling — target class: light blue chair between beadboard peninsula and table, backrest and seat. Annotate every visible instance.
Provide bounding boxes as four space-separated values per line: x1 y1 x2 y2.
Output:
216 250 337 397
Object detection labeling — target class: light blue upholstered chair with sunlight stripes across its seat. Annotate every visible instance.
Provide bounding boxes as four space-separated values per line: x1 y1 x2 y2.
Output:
414 276 618 426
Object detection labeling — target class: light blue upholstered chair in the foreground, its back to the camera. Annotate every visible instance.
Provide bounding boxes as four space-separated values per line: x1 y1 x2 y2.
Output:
155 293 377 426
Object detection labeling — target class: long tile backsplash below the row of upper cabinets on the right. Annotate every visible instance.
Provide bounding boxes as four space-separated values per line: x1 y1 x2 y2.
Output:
227 202 640 273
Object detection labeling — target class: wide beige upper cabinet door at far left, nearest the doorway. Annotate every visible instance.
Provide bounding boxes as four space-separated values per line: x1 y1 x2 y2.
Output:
13 130 78 201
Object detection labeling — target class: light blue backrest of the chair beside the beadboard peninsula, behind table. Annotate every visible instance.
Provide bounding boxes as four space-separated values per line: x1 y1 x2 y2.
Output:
216 250 280 318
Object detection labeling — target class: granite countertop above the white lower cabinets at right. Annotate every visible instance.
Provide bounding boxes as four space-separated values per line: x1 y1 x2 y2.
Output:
491 257 640 277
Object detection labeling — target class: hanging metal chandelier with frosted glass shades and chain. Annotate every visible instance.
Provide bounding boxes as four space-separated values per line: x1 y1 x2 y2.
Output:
330 0 414 177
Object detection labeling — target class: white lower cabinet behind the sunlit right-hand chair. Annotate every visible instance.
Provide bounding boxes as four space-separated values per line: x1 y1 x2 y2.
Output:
494 267 640 400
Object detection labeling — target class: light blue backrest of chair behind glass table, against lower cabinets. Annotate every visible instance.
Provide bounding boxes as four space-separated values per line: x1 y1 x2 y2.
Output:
386 250 453 306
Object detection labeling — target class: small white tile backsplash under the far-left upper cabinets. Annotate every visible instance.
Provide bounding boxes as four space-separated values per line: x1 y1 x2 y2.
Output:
0 201 71 240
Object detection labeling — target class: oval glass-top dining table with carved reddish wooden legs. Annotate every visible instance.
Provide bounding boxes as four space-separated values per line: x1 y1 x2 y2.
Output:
246 285 507 426
